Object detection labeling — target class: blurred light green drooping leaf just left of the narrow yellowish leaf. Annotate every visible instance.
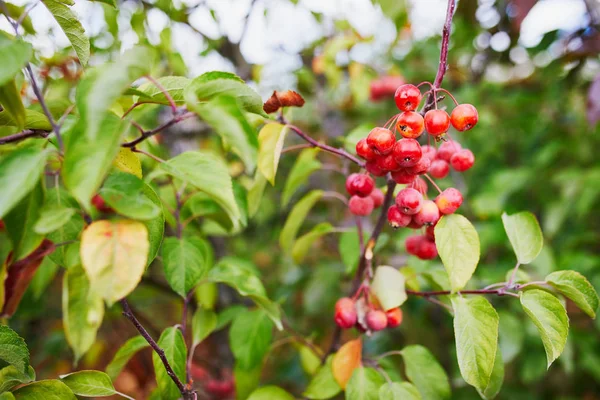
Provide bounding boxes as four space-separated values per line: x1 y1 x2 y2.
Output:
191 96 258 174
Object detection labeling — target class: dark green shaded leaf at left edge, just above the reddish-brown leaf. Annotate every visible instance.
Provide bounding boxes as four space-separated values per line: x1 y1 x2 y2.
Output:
4 183 44 261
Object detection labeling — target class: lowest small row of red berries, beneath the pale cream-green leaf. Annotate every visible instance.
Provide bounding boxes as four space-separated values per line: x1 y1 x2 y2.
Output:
334 297 402 332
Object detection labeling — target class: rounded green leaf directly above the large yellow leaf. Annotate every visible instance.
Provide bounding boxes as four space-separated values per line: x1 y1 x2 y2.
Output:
99 172 162 221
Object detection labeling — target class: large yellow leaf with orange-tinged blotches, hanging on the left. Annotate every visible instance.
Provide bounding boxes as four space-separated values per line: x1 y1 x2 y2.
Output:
80 220 150 305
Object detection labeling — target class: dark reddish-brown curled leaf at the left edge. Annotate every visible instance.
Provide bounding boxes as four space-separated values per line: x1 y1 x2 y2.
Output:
0 239 55 318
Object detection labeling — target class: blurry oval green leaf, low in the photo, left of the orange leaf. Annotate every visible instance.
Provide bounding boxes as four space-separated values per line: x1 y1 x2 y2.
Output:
229 310 273 370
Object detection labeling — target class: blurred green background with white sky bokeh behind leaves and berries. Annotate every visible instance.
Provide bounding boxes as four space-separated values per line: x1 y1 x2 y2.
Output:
0 0 600 400
